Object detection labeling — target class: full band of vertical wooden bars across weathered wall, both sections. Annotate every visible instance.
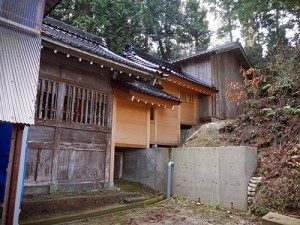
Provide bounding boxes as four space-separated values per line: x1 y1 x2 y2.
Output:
35 79 109 127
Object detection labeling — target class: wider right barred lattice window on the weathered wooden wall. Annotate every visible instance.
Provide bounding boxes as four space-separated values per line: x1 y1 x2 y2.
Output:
62 85 108 127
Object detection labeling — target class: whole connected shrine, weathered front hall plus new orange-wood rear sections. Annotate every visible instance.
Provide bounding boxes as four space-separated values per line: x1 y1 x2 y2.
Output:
25 18 217 194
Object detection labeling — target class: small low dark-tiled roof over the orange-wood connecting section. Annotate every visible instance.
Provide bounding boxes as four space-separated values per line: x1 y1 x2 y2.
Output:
113 80 181 103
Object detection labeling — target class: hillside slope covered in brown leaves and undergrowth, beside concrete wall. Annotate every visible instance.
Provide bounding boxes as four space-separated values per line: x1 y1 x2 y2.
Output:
185 71 300 217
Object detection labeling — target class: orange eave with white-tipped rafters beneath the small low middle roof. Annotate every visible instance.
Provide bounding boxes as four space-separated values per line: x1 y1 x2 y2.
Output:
112 83 180 109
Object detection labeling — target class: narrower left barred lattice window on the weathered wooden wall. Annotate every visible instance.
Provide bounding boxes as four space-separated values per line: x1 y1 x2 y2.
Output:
35 79 59 120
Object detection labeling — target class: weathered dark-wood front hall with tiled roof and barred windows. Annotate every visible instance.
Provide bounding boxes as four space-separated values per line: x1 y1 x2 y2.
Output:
25 18 164 194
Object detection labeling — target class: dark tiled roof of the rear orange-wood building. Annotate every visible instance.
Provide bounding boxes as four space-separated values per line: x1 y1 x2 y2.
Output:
124 45 216 90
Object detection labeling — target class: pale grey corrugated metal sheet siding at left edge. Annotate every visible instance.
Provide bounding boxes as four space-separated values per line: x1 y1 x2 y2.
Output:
0 24 41 124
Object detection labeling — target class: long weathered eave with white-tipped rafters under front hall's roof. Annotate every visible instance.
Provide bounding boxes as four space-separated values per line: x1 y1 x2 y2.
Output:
42 36 159 79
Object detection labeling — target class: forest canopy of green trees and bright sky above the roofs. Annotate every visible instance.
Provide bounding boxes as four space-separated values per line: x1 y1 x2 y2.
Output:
51 0 300 64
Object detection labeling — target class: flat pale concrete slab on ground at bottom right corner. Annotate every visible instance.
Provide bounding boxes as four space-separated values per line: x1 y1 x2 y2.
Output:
262 212 300 225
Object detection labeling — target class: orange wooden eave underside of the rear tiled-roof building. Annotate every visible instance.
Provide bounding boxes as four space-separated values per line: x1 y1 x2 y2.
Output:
163 74 218 95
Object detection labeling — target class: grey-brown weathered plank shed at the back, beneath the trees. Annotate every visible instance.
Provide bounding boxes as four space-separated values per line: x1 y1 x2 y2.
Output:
173 42 251 120
